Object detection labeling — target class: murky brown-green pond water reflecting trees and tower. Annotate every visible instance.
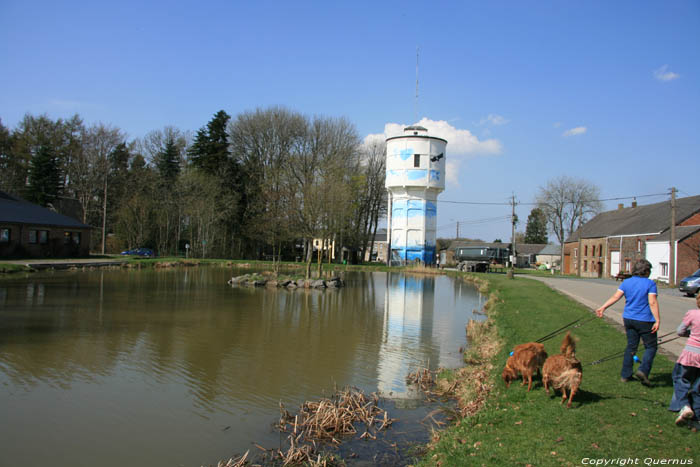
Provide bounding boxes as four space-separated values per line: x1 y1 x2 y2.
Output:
0 267 485 467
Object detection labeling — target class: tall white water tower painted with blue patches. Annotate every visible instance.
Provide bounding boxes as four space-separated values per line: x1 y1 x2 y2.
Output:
386 126 447 264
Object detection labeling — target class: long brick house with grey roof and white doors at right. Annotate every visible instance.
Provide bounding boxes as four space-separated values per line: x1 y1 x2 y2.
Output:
564 196 700 277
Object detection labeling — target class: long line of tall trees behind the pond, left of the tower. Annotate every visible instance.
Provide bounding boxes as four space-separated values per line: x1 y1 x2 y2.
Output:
0 107 386 272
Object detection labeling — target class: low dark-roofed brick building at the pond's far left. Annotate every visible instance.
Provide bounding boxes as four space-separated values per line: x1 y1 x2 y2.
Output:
0 191 92 258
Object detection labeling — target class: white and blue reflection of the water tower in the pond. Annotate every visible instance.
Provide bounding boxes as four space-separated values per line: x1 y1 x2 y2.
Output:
377 273 440 396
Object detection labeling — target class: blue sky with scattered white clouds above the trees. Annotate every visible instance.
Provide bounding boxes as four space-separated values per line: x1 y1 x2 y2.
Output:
0 0 700 241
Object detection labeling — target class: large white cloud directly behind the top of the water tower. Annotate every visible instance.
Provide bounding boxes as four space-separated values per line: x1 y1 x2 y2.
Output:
364 118 503 185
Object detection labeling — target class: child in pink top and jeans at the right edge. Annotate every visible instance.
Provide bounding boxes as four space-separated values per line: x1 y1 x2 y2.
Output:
670 293 700 425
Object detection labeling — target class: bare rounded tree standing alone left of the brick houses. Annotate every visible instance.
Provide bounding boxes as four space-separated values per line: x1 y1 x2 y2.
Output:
537 175 602 266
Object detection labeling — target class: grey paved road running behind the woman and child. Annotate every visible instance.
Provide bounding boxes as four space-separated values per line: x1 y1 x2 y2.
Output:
520 276 696 356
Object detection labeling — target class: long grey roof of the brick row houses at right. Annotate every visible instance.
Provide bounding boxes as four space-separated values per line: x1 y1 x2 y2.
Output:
566 196 700 243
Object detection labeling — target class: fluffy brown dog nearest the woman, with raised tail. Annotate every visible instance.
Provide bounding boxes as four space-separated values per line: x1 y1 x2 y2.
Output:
542 332 583 408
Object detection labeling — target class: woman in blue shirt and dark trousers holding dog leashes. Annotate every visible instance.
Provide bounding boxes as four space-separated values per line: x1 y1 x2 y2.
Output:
596 259 661 386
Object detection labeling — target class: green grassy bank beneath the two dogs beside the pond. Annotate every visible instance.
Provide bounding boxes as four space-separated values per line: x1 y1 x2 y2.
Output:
423 275 700 466
